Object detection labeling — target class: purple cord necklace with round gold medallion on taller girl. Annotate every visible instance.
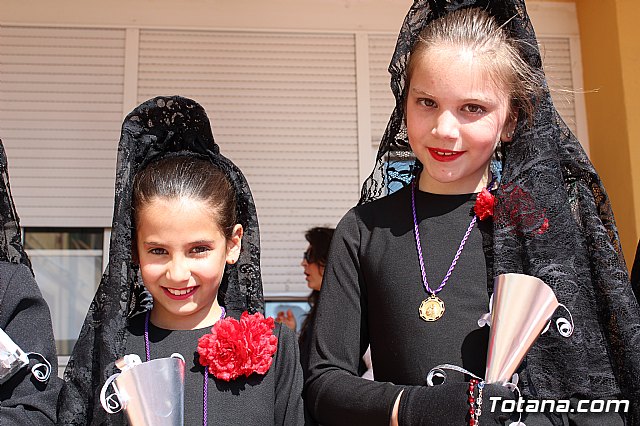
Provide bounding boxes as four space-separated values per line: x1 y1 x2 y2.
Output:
411 180 478 322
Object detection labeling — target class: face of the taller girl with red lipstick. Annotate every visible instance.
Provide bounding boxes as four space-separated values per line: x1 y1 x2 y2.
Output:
405 46 515 194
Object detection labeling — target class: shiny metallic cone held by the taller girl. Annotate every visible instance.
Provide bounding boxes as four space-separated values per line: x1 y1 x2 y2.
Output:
485 274 559 384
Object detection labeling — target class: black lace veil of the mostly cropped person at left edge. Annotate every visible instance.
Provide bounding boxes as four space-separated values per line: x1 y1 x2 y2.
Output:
0 140 31 269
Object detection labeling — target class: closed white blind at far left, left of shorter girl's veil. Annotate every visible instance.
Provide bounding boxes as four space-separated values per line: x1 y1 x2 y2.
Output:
0 26 124 227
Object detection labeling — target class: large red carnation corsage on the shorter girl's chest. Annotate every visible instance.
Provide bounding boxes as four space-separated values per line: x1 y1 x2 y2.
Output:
198 312 278 381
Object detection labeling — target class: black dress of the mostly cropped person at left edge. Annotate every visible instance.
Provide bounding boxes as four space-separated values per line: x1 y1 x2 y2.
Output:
0 262 62 426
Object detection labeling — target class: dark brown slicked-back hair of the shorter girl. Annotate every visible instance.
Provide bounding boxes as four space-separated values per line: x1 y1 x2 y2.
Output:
132 156 237 239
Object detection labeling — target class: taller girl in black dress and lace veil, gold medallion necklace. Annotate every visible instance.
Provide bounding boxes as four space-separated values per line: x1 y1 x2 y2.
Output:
306 0 640 426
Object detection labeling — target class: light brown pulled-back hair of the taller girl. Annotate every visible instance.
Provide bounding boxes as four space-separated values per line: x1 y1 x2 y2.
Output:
406 8 544 121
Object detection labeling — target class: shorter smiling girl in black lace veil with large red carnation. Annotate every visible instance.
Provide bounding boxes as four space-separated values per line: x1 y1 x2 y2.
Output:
59 97 303 425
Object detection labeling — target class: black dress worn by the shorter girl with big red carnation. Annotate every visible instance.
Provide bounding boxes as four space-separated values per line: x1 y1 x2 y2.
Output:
116 315 304 426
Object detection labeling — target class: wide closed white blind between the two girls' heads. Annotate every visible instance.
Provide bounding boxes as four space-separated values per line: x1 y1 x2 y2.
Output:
138 30 360 294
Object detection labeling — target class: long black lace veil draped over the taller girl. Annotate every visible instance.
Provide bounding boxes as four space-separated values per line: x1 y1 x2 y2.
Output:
360 0 640 424
